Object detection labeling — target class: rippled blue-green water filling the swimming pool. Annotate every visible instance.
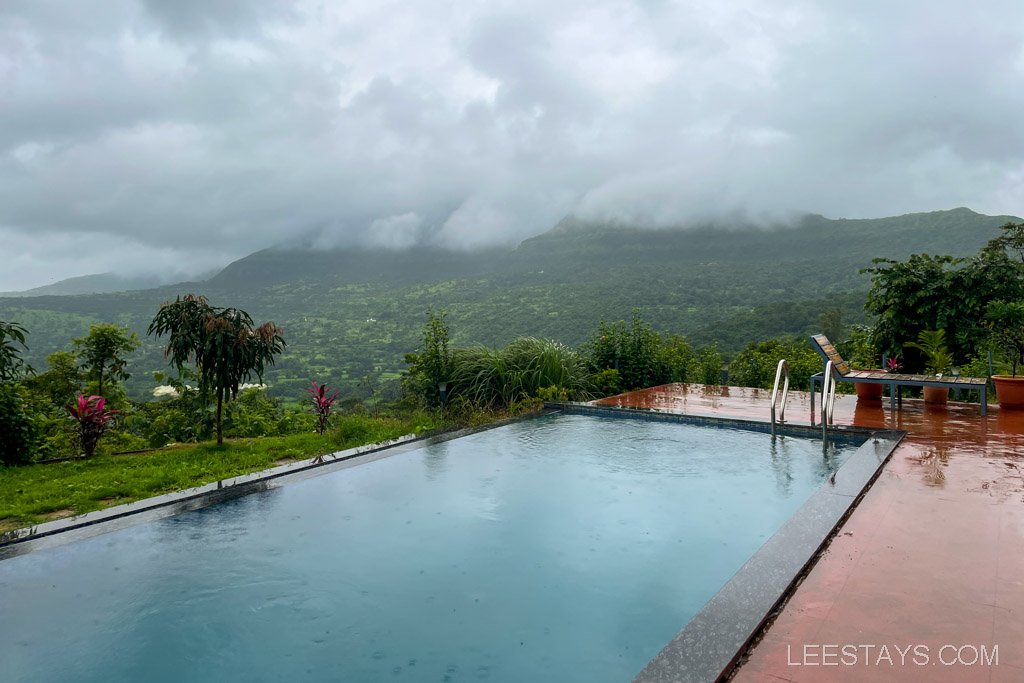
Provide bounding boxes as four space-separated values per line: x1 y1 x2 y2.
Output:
0 415 856 683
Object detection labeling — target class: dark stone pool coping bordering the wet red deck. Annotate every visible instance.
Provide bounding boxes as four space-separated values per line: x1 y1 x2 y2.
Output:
550 403 906 683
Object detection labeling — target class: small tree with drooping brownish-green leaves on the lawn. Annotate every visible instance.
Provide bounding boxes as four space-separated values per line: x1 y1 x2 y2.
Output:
147 294 286 445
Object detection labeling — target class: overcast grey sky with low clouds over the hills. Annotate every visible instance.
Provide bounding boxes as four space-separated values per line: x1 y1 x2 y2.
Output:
0 0 1024 291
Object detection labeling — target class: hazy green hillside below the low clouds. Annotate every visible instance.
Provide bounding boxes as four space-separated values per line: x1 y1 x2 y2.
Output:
0 209 1019 396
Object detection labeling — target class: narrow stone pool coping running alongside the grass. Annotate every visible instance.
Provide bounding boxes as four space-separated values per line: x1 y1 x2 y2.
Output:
0 409 554 560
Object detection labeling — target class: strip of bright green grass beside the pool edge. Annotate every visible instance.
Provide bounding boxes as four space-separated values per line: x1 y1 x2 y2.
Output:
0 413 440 532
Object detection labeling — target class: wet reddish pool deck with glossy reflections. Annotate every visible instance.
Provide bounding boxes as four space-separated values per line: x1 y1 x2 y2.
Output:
594 384 1024 682
